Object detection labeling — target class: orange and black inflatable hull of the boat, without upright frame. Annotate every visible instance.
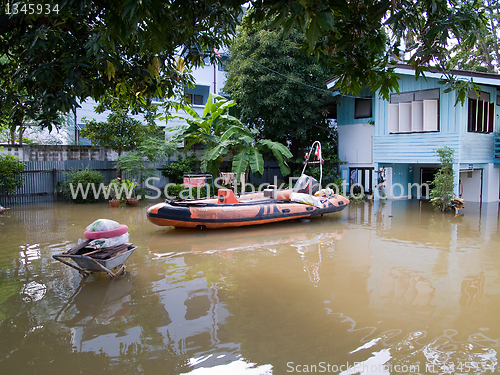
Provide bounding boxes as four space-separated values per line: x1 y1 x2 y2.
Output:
147 195 349 229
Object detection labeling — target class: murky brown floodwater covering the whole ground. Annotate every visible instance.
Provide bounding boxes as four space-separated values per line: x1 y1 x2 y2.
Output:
0 201 500 375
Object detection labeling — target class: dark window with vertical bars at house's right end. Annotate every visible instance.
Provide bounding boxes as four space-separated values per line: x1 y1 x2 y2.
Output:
467 91 495 133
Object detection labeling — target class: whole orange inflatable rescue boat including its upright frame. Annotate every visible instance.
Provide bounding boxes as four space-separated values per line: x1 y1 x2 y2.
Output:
147 142 349 229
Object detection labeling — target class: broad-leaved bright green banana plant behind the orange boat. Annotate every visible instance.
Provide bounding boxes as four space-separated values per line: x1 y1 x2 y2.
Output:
167 94 293 176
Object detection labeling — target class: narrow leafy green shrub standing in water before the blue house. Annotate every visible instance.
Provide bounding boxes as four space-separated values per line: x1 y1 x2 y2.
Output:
430 146 455 211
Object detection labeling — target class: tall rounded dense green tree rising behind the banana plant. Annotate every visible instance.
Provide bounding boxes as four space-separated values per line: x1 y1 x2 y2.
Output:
224 12 334 154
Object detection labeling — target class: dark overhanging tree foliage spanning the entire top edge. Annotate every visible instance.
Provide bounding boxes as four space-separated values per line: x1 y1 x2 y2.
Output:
0 0 485 128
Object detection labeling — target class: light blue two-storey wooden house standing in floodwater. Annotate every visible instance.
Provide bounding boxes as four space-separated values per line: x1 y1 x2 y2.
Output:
328 65 500 202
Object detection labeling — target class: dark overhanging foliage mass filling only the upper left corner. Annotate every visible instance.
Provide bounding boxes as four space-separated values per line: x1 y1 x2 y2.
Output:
0 0 241 127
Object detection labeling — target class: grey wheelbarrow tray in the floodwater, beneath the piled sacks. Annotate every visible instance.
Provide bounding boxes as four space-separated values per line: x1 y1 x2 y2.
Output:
52 240 137 277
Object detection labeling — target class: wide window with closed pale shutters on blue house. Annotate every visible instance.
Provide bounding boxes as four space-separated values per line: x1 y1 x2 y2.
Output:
388 89 439 134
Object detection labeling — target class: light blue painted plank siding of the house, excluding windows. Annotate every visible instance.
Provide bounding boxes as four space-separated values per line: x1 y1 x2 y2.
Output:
337 70 500 202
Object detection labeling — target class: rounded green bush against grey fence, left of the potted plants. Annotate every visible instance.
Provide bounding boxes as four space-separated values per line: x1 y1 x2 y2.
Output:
63 168 103 203
